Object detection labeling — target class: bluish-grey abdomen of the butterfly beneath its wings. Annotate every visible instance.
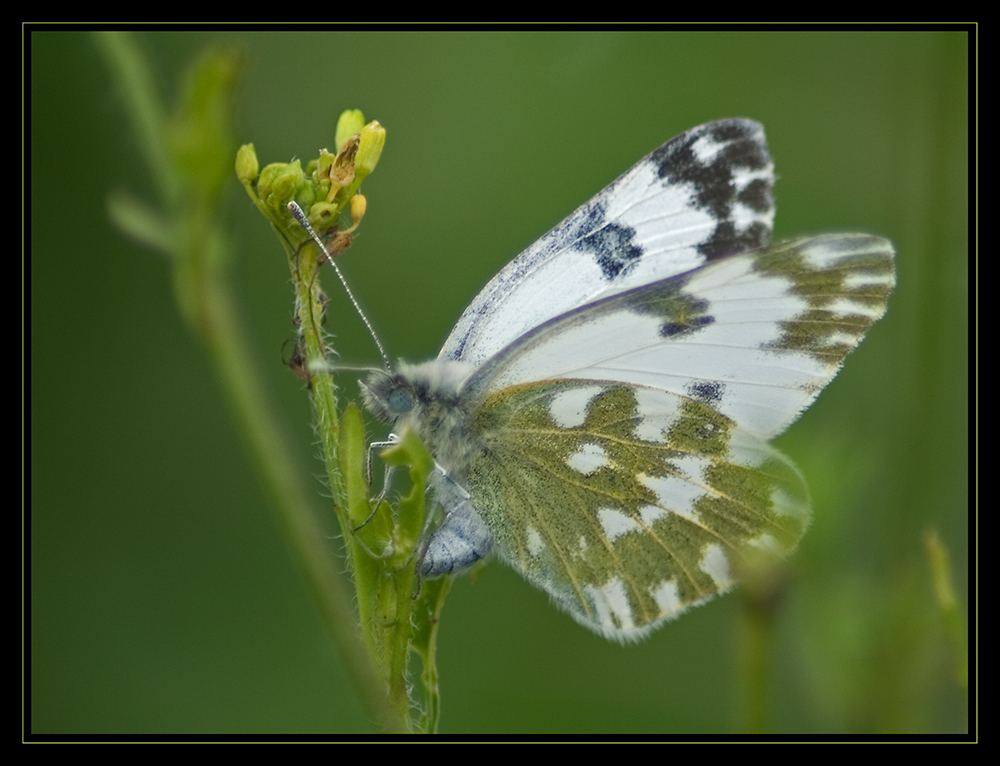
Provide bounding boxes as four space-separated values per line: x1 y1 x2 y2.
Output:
419 467 493 577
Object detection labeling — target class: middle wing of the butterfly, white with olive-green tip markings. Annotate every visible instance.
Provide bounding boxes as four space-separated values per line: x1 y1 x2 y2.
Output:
468 234 894 439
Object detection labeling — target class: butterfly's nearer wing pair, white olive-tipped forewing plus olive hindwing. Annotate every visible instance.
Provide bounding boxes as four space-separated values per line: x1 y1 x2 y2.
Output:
458 234 894 641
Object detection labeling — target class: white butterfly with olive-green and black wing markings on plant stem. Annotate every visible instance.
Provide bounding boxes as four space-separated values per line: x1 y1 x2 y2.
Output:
363 119 895 642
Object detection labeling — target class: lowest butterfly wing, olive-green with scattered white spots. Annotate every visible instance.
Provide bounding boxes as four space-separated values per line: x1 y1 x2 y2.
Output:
469 380 808 640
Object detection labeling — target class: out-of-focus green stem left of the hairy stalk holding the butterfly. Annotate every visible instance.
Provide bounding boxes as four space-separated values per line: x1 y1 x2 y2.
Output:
94 33 426 731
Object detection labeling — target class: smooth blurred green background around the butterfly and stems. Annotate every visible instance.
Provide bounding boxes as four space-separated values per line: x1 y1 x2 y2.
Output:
28 29 969 736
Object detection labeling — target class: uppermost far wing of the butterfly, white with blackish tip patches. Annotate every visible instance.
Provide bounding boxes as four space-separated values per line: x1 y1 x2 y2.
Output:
439 119 774 366
